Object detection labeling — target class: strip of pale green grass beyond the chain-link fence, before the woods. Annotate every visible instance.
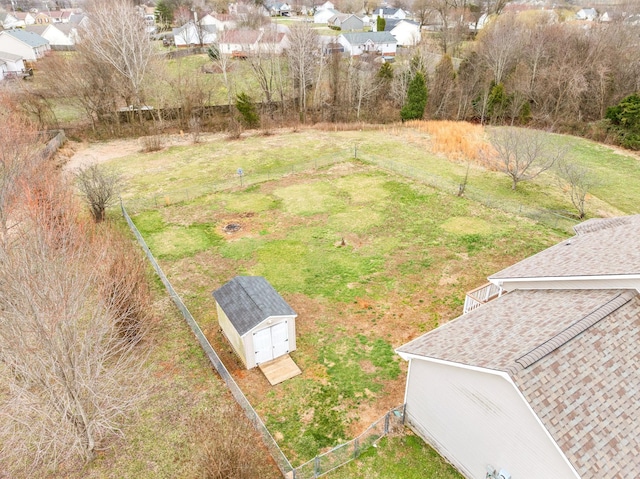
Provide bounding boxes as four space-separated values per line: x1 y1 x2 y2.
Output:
115 127 640 225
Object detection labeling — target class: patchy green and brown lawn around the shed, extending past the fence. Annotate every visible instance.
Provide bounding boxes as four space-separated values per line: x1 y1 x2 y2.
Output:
99 122 640 478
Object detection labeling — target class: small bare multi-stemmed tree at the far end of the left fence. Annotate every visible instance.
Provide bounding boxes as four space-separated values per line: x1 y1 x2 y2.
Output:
76 165 120 223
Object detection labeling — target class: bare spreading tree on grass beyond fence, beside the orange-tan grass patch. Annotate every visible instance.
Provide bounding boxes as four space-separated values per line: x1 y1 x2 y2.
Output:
487 127 566 190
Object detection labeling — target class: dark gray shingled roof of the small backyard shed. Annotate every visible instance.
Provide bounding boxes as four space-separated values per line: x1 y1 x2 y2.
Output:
213 276 297 336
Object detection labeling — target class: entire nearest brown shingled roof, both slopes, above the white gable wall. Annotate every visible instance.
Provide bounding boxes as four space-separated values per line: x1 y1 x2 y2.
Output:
398 290 640 478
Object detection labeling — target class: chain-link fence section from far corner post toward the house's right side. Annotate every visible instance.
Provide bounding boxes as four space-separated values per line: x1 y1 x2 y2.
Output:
358 148 579 233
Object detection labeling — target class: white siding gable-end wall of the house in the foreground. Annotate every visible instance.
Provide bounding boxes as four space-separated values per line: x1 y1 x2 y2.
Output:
406 358 578 479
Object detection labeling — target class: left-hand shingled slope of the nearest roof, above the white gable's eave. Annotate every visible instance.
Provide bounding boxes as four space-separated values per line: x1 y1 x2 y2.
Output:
398 289 633 373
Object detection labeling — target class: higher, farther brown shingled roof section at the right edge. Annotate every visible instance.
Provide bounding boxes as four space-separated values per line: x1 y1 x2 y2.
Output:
489 215 640 280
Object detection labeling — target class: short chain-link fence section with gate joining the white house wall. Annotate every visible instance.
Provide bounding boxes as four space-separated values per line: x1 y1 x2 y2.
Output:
293 406 404 479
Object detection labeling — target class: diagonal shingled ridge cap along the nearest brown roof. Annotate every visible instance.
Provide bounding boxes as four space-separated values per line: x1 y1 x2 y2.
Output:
507 290 638 374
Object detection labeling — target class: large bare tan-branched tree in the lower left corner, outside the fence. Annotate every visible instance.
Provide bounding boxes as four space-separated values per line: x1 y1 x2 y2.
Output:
0 202 149 477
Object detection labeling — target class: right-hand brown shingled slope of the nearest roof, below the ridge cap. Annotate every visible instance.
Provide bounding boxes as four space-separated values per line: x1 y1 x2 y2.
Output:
514 297 640 478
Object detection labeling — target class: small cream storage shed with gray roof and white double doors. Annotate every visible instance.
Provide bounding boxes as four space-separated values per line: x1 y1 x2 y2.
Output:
213 276 297 369
